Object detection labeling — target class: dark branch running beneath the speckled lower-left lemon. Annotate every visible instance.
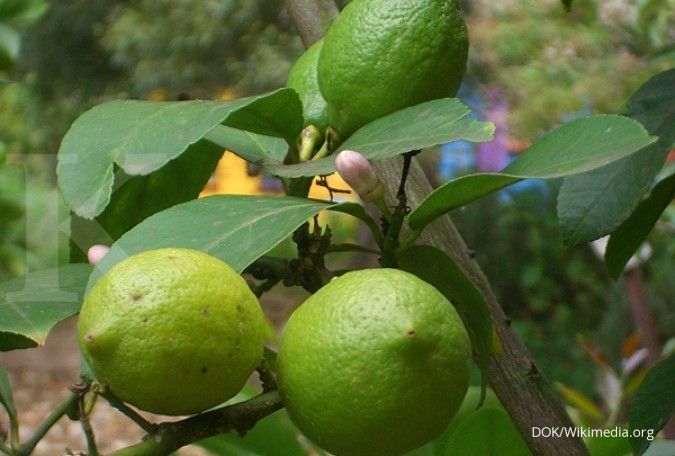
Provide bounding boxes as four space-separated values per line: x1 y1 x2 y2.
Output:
110 391 282 456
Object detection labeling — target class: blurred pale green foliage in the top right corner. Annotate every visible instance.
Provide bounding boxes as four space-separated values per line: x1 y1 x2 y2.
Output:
468 0 675 141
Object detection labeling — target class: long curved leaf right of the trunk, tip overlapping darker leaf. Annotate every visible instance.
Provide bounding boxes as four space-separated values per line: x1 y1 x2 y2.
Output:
408 115 657 230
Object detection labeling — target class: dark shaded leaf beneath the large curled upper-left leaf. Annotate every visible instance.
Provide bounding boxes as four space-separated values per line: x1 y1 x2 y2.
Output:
71 139 224 261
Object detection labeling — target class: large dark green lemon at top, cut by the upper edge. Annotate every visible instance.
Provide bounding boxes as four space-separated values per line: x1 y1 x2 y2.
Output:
318 0 469 138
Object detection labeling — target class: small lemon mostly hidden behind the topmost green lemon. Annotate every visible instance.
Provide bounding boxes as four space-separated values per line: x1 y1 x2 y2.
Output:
286 40 328 132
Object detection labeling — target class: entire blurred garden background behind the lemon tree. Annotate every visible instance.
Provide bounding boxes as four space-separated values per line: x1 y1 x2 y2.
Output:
0 0 675 454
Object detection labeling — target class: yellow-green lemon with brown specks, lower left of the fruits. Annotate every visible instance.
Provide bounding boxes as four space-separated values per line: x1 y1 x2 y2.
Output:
78 248 265 415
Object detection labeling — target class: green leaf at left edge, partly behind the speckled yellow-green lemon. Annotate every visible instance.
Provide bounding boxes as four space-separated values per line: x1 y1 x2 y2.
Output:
0 264 91 351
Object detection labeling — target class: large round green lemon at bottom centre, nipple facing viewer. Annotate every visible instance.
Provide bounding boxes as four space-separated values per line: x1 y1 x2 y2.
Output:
277 269 471 456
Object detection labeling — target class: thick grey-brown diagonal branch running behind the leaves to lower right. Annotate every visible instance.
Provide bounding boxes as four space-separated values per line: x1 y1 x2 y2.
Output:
286 0 588 456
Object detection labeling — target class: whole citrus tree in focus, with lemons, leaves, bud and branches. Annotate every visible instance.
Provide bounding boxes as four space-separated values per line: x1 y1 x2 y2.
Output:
0 0 675 455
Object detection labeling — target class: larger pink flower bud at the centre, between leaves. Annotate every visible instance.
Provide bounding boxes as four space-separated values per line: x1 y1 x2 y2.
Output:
335 150 384 202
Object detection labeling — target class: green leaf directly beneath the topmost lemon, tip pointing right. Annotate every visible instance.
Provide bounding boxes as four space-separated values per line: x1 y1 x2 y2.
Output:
267 98 494 177
